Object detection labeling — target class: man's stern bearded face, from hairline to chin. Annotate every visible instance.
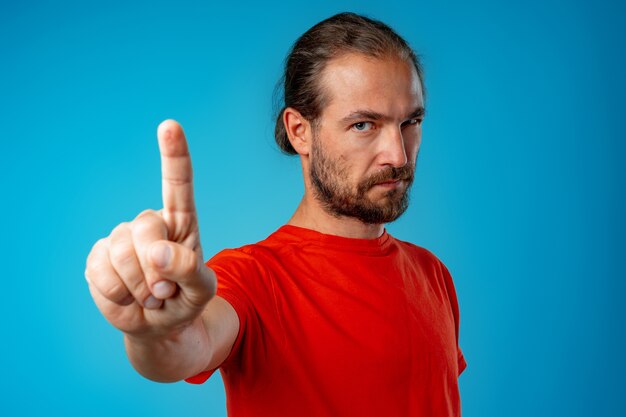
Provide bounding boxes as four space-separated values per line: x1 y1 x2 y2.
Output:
309 54 424 224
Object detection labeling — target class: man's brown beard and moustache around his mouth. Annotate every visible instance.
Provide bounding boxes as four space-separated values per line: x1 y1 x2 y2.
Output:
310 134 415 224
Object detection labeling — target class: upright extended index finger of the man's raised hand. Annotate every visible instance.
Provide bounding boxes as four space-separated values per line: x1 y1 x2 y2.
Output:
157 120 196 225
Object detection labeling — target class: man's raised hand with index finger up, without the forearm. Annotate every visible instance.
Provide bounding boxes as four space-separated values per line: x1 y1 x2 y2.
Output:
85 120 216 337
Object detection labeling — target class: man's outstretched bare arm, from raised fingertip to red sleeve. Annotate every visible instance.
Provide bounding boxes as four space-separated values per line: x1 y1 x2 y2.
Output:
85 120 239 382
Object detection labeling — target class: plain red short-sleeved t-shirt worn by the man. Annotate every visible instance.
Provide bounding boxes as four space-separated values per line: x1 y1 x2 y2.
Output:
187 226 466 417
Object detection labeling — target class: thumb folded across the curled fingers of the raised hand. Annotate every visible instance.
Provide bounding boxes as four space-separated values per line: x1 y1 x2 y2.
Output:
148 240 217 306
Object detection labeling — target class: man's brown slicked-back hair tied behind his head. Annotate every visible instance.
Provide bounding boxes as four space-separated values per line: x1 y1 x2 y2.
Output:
274 13 425 155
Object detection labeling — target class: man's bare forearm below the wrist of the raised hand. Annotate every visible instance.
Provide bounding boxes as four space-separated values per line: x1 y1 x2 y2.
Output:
124 319 211 382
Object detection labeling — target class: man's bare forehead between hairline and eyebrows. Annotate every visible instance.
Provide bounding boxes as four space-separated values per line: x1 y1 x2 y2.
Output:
320 53 424 117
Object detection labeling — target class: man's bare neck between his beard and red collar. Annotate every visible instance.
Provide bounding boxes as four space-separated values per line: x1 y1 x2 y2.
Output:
287 194 385 239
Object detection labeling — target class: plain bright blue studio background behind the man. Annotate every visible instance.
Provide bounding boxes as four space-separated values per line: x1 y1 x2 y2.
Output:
0 0 626 417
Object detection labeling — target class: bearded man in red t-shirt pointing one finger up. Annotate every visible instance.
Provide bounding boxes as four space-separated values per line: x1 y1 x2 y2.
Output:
86 13 465 417
